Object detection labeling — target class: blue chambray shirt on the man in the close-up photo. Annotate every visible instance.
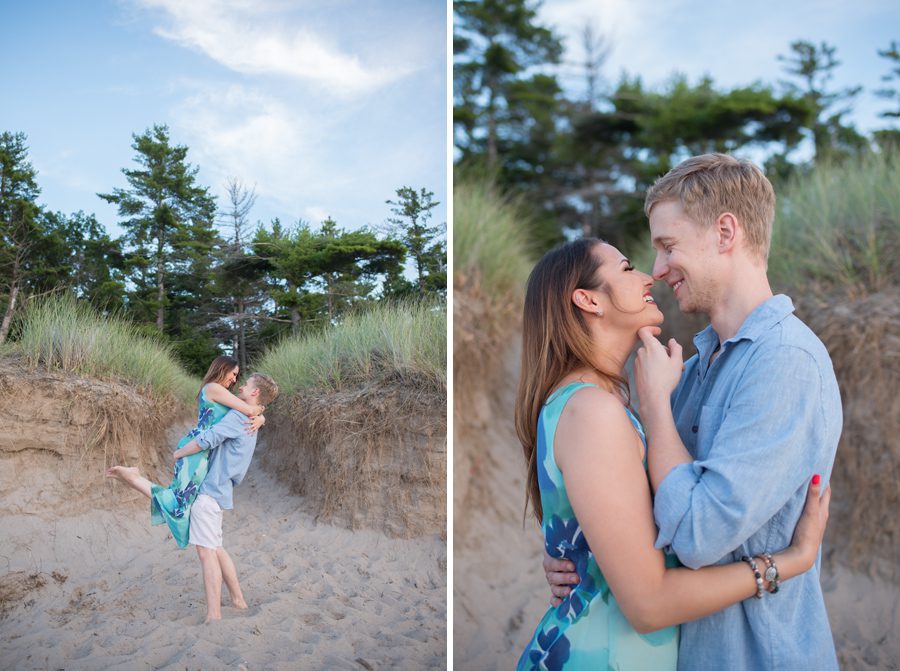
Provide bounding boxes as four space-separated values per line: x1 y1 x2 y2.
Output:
651 295 842 671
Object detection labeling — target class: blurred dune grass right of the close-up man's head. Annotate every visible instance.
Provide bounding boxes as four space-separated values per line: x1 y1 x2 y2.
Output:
769 153 900 297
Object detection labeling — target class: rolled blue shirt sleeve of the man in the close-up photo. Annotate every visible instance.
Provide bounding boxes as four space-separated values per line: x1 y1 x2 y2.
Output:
654 345 827 568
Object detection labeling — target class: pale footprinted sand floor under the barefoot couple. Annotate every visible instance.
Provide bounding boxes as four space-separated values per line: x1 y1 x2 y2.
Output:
0 465 446 671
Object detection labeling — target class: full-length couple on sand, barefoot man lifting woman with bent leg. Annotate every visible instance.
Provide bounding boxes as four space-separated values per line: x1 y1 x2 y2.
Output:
106 356 278 623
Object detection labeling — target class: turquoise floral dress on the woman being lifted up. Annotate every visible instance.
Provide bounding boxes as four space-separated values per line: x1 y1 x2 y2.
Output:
150 387 230 548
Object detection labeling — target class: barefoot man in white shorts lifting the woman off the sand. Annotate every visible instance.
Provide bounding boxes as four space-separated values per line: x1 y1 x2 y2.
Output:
174 373 278 622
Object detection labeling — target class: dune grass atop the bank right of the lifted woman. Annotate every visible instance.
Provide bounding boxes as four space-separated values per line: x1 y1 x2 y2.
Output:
252 301 447 396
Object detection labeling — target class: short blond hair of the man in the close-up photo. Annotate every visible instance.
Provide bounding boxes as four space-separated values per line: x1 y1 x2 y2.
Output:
644 154 775 263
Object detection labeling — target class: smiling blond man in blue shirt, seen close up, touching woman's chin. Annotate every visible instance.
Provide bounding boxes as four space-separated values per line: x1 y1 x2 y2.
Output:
545 154 842 671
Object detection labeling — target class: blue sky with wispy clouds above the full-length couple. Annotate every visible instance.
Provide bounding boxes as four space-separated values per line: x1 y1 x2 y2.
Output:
0 0 447 236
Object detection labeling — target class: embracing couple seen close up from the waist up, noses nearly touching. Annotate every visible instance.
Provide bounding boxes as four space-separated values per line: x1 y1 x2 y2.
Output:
516 154 842 671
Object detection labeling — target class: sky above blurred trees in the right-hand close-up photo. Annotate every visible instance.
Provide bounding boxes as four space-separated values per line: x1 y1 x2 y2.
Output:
539 0 900 146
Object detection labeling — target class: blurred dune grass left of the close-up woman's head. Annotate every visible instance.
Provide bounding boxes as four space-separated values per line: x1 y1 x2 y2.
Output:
453 175 534 299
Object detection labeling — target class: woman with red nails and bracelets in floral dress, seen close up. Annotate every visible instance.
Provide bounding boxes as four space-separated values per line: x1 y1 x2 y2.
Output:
516 239 830 671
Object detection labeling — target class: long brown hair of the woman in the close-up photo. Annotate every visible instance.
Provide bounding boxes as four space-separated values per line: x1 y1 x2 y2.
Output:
516 238 628 522
